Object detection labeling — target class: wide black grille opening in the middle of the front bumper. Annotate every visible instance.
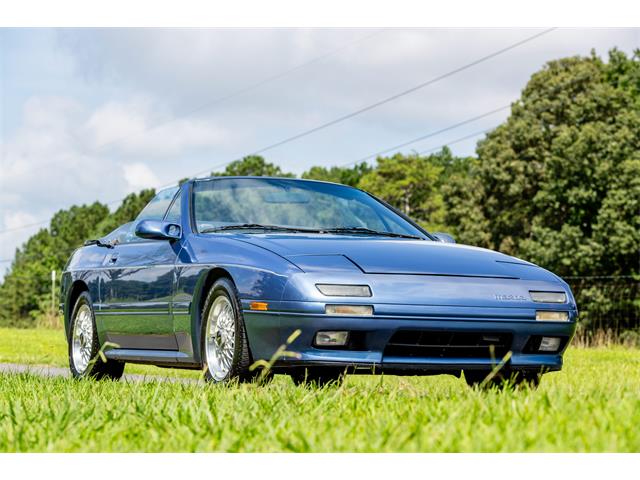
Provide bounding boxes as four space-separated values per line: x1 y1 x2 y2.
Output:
384 330 513 360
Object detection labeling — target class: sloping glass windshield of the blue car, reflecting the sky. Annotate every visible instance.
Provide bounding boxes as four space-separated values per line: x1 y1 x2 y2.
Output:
193 178 425 238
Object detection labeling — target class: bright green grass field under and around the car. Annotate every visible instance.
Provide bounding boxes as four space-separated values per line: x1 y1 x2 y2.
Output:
0 329 640 452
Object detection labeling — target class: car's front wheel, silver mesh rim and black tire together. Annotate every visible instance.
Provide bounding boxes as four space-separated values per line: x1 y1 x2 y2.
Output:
201 278 257 383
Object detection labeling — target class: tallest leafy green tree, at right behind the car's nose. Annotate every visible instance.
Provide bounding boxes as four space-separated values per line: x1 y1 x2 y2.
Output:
449 50 640 275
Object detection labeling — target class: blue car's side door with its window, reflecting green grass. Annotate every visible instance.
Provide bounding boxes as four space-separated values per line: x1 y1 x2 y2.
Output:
100 187 181 350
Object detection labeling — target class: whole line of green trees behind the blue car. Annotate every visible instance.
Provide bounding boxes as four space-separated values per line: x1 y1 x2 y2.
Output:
0 49 640 330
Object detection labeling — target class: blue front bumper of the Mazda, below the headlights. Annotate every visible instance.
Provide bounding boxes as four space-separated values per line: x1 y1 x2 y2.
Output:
243 302 577 374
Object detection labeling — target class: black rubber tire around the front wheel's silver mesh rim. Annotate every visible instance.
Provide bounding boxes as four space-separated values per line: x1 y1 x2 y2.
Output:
200 278 254 383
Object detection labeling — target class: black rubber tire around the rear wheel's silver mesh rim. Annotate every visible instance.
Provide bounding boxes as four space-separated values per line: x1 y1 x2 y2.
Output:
67 292 125 380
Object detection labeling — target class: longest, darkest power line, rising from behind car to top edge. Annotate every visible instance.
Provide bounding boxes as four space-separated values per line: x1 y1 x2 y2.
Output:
0 27 557 234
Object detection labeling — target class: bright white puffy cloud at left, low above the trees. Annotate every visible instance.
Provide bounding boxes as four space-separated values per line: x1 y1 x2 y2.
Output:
0 96 233 276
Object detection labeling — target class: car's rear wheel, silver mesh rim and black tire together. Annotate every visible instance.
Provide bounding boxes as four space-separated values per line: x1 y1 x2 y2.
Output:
68 292 124 380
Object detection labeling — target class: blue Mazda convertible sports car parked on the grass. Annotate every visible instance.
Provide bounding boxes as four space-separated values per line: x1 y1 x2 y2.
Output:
62 177 577 385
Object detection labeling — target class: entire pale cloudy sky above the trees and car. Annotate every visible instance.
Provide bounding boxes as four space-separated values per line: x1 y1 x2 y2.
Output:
0 29 640 274
